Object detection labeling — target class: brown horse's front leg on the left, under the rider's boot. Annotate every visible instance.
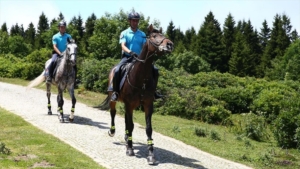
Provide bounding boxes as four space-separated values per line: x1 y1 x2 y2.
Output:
125 104 134 156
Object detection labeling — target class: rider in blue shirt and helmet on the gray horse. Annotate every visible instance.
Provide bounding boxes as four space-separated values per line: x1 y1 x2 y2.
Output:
46 20 77 83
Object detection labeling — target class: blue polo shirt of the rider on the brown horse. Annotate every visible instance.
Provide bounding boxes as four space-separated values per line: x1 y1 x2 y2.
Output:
119 27 146 55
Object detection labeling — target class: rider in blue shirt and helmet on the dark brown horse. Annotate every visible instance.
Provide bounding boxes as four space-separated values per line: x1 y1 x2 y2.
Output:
111 11 163 102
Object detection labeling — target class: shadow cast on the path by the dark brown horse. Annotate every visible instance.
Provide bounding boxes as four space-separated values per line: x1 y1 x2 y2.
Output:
114 142 207 169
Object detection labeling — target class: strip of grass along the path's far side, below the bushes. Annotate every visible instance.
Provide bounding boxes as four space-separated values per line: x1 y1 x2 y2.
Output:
0 78 300 169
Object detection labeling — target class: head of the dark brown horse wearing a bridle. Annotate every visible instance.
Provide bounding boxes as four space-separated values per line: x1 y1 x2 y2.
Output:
148 24 174 55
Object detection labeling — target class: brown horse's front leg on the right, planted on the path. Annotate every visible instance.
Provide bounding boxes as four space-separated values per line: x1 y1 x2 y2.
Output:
144 102 155 164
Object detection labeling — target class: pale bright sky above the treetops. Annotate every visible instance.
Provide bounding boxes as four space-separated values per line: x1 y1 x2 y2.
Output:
0 0 300 34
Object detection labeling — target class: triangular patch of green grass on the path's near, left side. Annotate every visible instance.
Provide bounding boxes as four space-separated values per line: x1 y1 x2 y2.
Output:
0 108 104 169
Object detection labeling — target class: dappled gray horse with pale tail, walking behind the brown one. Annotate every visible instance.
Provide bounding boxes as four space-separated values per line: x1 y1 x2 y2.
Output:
28 39 77 122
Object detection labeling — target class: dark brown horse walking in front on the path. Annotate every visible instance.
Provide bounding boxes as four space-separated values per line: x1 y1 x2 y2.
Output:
99 25 173 164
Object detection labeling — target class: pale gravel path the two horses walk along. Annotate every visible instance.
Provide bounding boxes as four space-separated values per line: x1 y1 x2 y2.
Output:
0 82 253 169
